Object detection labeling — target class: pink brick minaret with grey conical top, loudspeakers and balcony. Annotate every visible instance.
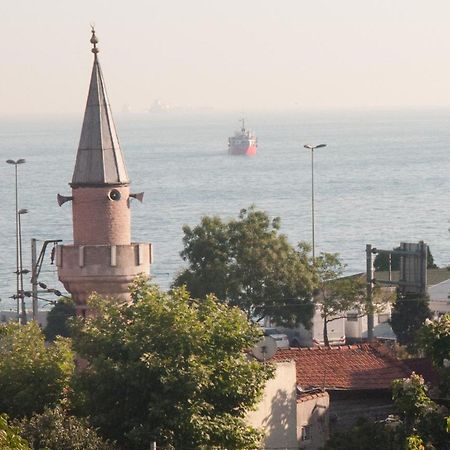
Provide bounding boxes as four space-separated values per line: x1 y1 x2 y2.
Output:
56 28 152 316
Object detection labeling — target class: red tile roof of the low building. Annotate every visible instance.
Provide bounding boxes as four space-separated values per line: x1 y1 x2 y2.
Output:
273 344 420 390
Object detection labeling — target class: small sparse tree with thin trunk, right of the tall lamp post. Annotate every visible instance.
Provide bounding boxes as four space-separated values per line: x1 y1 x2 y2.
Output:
314 253 390 345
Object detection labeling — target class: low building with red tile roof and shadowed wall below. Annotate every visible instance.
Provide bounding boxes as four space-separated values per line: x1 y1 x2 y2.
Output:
270 343 431 432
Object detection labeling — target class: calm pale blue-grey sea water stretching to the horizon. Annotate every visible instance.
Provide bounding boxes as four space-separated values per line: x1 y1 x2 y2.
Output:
0 110 450 309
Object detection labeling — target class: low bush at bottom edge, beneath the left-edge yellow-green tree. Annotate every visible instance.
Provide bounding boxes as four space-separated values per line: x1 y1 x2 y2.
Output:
19 406 115 450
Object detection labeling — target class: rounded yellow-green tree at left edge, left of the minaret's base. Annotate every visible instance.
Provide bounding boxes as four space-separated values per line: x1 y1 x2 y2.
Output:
0 322 74 418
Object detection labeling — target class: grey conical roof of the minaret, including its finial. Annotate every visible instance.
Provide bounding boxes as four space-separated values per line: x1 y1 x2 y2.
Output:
71 29 130 187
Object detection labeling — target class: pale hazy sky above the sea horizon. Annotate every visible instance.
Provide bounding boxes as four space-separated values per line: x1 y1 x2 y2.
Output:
0 0 450 115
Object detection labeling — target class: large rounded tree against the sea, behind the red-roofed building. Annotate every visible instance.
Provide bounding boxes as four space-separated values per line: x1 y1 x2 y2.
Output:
174 207 314 327
